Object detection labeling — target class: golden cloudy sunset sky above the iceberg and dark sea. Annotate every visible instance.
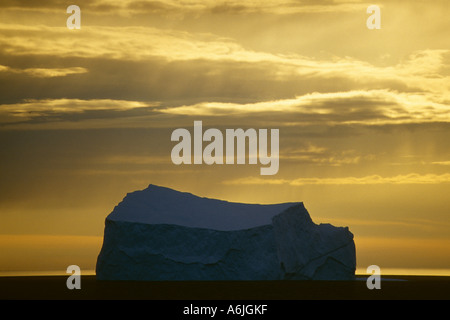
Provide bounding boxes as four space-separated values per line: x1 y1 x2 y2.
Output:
0 0 450 271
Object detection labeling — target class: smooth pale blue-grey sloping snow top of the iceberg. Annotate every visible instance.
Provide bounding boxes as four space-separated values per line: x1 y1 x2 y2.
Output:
103 185 295 231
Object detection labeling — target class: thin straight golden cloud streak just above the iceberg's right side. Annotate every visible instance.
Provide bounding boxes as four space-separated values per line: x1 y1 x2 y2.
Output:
224 173 450 187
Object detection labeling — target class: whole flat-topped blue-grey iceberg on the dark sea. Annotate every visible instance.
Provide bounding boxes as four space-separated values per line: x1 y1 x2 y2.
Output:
96 185 356 280
